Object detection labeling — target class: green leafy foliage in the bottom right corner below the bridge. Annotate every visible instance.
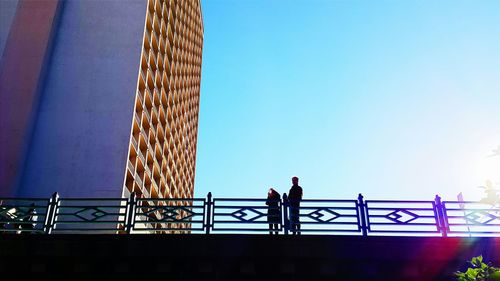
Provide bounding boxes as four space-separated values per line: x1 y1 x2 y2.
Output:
455 256 500 281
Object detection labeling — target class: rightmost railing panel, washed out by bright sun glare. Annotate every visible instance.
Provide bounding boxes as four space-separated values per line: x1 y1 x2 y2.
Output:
443 201 500 236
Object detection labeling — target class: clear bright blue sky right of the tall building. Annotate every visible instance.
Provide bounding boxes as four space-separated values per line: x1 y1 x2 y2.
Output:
195 0 500 200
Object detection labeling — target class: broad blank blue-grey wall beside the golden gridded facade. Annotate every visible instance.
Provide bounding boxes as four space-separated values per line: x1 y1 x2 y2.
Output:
16 0 147 197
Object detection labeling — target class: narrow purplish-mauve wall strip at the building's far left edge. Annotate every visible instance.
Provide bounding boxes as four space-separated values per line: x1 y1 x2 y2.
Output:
0 0 61 196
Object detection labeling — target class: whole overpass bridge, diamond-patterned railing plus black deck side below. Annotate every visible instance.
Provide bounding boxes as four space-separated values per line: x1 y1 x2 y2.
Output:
0 191 500 276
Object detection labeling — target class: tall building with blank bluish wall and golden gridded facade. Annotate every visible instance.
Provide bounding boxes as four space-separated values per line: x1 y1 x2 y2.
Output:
0 0 203 198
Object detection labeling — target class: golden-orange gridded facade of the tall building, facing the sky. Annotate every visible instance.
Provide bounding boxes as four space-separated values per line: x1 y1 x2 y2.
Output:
124 0 203 198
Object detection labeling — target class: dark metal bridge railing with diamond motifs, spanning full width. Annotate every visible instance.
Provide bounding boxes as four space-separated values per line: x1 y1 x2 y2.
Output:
0 193 500 237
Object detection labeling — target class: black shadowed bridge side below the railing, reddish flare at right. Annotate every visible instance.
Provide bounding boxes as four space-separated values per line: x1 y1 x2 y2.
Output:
0 234 500 281
